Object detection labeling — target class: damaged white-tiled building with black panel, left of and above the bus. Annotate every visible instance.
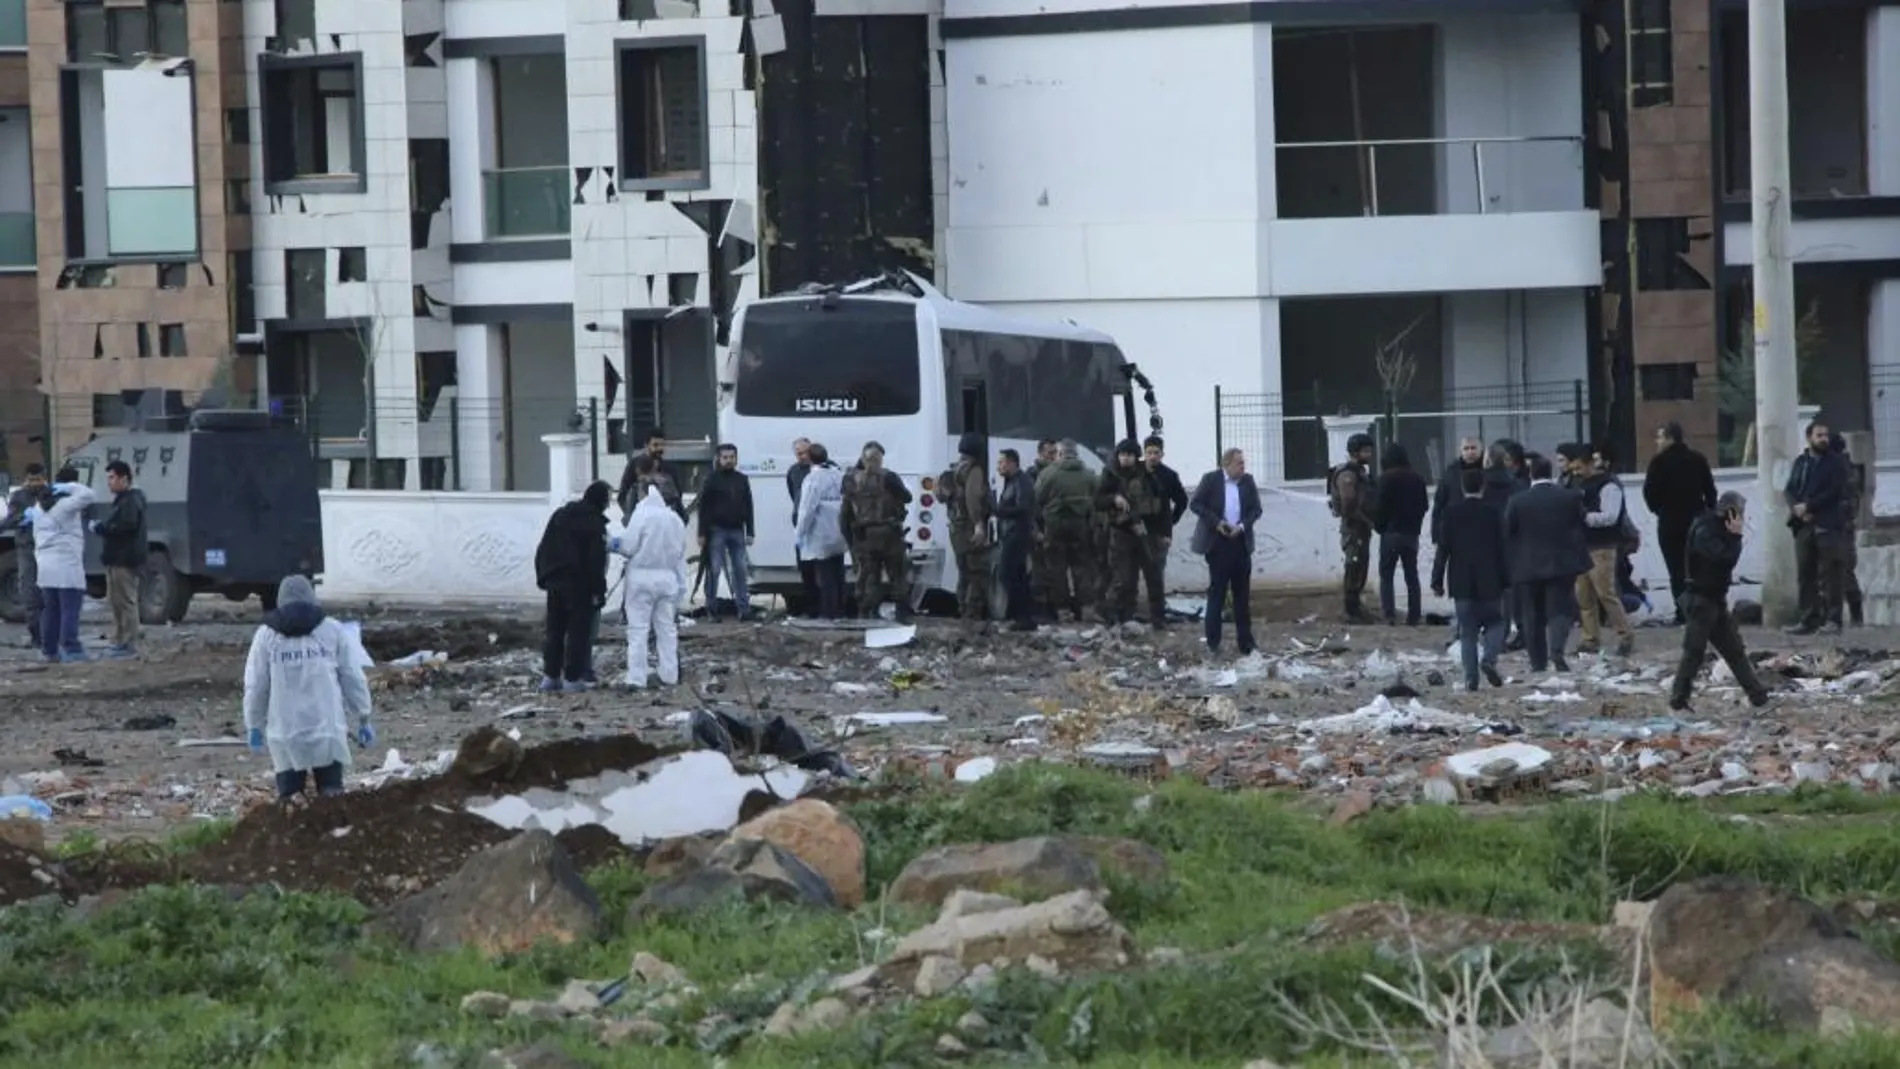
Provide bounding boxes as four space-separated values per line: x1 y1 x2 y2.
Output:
238 0 944 490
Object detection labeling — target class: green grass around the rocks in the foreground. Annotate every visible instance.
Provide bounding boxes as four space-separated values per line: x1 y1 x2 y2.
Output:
0 765 1900 1069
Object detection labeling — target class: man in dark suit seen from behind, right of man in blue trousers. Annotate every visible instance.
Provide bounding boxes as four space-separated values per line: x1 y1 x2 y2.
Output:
1505 456 1590 672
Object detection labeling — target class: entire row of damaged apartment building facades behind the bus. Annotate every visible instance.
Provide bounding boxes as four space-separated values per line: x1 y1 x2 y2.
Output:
11 0 1900 490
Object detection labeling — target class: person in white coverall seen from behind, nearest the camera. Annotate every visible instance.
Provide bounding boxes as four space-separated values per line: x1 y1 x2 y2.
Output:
243 575 376 801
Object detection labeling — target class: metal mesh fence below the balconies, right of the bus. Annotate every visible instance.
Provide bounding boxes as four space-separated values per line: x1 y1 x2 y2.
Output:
1214 378 1590 480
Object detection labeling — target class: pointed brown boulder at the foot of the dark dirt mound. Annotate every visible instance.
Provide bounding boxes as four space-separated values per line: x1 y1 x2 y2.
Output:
380 830 600 957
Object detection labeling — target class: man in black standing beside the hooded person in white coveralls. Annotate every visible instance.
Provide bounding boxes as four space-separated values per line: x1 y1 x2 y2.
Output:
534 478 608 693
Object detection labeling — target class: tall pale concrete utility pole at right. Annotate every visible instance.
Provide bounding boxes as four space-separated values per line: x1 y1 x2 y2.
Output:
1748 0 1803 627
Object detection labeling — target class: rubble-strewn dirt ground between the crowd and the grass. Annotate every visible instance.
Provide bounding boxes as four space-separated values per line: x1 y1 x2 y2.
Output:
0 598 1900 898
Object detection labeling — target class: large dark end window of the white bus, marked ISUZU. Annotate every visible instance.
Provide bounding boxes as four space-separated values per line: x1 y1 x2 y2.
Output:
733 296 922 418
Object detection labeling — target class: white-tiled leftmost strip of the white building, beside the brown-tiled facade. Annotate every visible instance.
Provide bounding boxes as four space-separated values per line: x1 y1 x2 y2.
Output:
239 0 437 490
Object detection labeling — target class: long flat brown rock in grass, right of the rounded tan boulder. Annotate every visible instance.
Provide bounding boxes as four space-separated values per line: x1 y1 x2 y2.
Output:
891 835 1169 906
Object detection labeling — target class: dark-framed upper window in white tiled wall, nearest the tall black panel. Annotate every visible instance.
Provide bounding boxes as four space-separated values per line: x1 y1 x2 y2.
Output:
619 40 709 190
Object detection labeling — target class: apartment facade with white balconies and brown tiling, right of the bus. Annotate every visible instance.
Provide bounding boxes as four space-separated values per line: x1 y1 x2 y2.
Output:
941 0 1900 478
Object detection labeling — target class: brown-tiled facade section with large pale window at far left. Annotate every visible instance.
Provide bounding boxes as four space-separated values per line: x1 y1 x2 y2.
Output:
21 0 255 456
